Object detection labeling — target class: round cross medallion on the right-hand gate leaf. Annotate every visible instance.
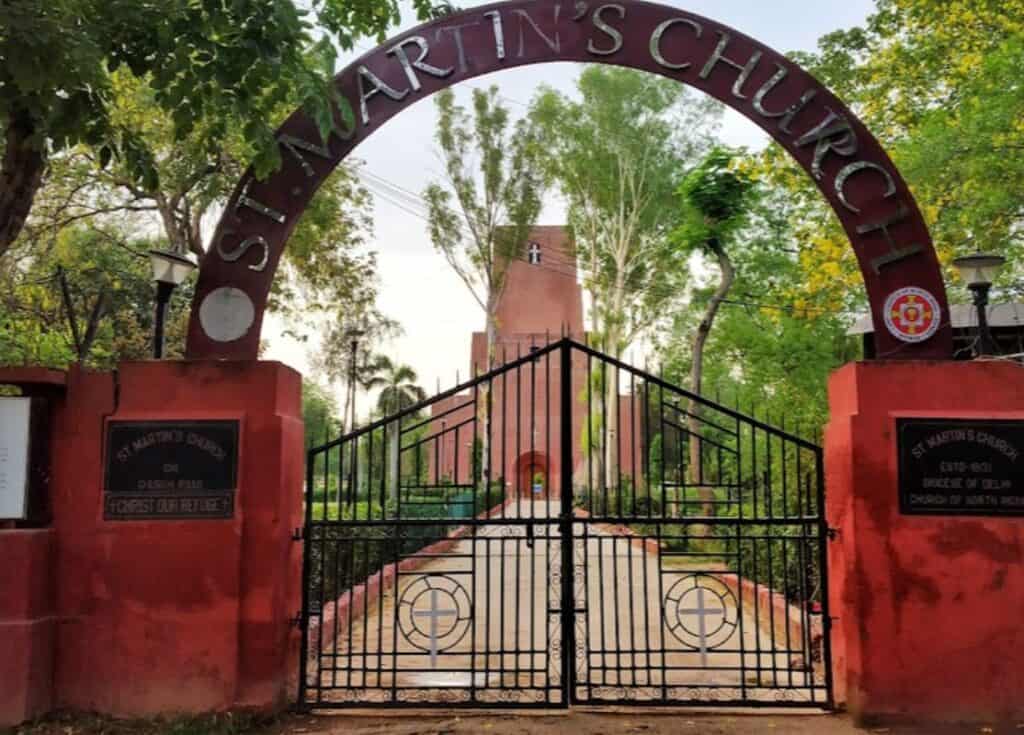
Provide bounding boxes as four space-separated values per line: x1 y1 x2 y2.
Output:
665 574 739 654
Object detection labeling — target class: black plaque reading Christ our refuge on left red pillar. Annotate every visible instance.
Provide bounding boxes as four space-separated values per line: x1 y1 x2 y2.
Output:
103 421 239 520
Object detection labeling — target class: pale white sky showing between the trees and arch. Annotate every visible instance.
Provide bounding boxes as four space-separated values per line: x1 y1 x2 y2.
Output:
263 0 873 414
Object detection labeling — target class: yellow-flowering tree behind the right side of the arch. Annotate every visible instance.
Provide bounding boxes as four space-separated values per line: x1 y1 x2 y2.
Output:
762 0 1024 309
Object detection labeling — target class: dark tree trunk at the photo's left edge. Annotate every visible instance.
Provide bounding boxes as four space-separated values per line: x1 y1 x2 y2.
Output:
0 111 46 256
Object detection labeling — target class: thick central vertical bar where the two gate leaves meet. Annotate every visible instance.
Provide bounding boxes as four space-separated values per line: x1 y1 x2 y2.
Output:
559 339 587 706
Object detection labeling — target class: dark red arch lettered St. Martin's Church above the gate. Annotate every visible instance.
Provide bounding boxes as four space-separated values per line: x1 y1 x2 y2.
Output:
186 0 952 359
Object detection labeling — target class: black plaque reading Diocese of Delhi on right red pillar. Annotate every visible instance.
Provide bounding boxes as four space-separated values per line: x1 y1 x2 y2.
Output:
896 419 1024 516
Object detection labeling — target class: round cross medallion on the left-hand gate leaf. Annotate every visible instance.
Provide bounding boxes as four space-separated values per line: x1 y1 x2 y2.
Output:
398 574 472 662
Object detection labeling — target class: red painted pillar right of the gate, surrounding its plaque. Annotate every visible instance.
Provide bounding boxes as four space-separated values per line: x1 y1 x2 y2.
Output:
825 361 1024 722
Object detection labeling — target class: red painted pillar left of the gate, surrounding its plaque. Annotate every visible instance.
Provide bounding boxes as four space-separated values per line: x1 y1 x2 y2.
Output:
0 362 303 722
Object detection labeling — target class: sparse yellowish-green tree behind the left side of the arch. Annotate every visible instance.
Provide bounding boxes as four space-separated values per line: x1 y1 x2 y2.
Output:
18 63 376 341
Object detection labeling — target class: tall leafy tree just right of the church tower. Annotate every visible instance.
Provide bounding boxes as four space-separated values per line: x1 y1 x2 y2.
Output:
531 67 719 486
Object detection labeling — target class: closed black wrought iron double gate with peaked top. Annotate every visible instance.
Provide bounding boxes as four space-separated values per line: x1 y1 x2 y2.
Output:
299 339 831 708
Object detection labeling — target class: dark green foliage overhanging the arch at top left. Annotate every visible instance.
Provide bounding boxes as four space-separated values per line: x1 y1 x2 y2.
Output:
0 0 433 256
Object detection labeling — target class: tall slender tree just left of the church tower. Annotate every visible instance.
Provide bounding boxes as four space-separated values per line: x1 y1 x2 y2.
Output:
425 87 545 491
